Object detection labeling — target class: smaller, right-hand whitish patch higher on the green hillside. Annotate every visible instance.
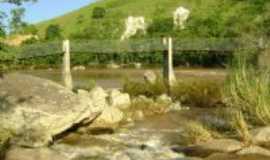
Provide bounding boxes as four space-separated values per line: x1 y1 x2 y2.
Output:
173 6 190 29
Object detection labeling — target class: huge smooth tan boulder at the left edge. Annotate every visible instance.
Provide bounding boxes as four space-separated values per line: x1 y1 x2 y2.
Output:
0 73 97 147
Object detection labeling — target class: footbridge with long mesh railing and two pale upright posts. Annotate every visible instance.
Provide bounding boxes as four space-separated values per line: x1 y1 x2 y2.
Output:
16 37 269 88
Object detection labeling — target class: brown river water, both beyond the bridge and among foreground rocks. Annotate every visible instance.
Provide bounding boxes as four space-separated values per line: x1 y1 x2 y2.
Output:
8 69 244 160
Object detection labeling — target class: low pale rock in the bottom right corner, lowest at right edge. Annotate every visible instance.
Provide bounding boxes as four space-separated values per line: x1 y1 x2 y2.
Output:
237 146 270 158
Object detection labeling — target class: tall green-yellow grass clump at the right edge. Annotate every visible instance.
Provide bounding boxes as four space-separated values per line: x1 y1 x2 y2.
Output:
225 50 270 125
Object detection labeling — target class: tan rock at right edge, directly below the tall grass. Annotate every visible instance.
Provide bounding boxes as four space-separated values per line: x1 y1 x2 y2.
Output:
251 127 270 144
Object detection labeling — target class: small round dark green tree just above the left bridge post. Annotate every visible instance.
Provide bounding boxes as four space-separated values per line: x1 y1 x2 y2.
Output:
45 24 62 40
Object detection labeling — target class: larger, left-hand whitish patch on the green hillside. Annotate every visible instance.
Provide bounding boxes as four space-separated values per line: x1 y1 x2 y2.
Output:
121 16 147 41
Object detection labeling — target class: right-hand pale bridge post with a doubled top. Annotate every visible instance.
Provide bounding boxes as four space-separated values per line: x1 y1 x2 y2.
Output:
163 37 176 87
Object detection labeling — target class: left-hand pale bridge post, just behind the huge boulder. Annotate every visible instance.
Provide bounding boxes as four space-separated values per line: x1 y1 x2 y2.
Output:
62 40 73 90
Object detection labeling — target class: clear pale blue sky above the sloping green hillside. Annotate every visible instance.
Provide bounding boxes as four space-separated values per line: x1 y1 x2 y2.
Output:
0 0 95 24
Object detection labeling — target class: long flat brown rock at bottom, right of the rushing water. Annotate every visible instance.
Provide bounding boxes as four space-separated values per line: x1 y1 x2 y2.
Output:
173 139 243 157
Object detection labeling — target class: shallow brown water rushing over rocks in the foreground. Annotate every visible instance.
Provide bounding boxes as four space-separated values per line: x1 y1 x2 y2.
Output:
52 109 206 160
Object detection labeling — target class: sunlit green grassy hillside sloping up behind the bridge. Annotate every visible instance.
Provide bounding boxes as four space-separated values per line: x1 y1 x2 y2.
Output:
37 0 270 39
